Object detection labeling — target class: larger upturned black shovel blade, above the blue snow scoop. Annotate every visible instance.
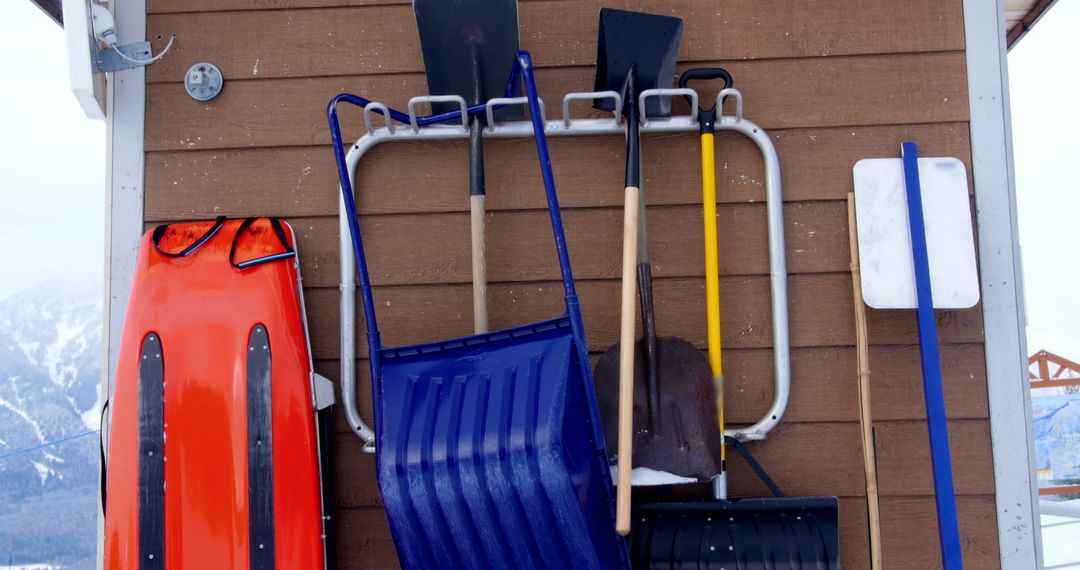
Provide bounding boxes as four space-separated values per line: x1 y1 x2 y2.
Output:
413 0 525 120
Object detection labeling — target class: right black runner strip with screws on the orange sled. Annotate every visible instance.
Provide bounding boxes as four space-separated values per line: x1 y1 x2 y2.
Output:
247 324 274 570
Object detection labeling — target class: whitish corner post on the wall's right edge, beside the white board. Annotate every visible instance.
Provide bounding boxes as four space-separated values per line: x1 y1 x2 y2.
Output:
961 0 1042 570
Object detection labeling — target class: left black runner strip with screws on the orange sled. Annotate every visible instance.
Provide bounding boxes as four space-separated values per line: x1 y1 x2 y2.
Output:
138 331 165 570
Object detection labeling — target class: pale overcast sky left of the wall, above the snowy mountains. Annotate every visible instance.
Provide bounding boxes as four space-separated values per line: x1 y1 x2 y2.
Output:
0 0 105 298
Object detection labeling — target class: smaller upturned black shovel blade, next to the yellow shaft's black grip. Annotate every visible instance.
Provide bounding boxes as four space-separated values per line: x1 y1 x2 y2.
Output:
594 8 683 117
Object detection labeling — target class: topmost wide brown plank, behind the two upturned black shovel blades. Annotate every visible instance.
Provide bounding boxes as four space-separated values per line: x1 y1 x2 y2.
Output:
147 0 964 83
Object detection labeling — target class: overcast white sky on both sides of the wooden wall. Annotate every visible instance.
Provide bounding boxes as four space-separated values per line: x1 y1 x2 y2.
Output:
0 0 1080 359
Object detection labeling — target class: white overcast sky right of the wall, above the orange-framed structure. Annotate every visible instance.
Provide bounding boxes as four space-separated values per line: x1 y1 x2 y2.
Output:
1009 1 1080 359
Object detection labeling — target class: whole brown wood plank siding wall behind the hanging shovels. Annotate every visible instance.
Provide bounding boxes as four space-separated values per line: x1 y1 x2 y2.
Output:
146 0 998 569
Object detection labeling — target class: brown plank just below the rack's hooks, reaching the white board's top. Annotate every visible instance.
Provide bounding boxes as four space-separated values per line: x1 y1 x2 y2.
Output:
146 123 971 221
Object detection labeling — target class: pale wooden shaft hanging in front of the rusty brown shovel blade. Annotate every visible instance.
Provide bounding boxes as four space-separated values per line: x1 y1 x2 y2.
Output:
615 186 640 535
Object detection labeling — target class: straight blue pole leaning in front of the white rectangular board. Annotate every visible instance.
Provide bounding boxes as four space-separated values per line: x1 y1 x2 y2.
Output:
901 143 963 570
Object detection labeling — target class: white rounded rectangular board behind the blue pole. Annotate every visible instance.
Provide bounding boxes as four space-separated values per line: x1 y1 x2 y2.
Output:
854 158 978 309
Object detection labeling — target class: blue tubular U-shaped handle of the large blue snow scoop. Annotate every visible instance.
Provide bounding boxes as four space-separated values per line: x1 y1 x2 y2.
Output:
326 50 582 356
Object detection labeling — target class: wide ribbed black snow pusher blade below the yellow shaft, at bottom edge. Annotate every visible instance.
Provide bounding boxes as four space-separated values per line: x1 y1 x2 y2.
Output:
631 497 840 570
